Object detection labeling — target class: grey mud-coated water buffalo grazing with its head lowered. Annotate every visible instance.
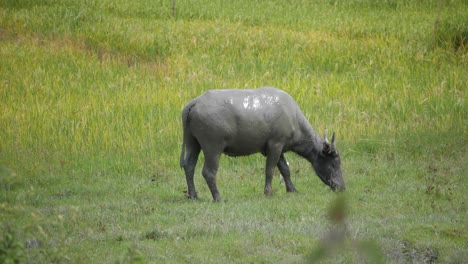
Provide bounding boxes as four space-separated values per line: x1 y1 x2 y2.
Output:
180 87 345 201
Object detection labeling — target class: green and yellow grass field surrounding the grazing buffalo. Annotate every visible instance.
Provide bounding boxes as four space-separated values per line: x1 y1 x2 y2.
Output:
0 0 468 263
